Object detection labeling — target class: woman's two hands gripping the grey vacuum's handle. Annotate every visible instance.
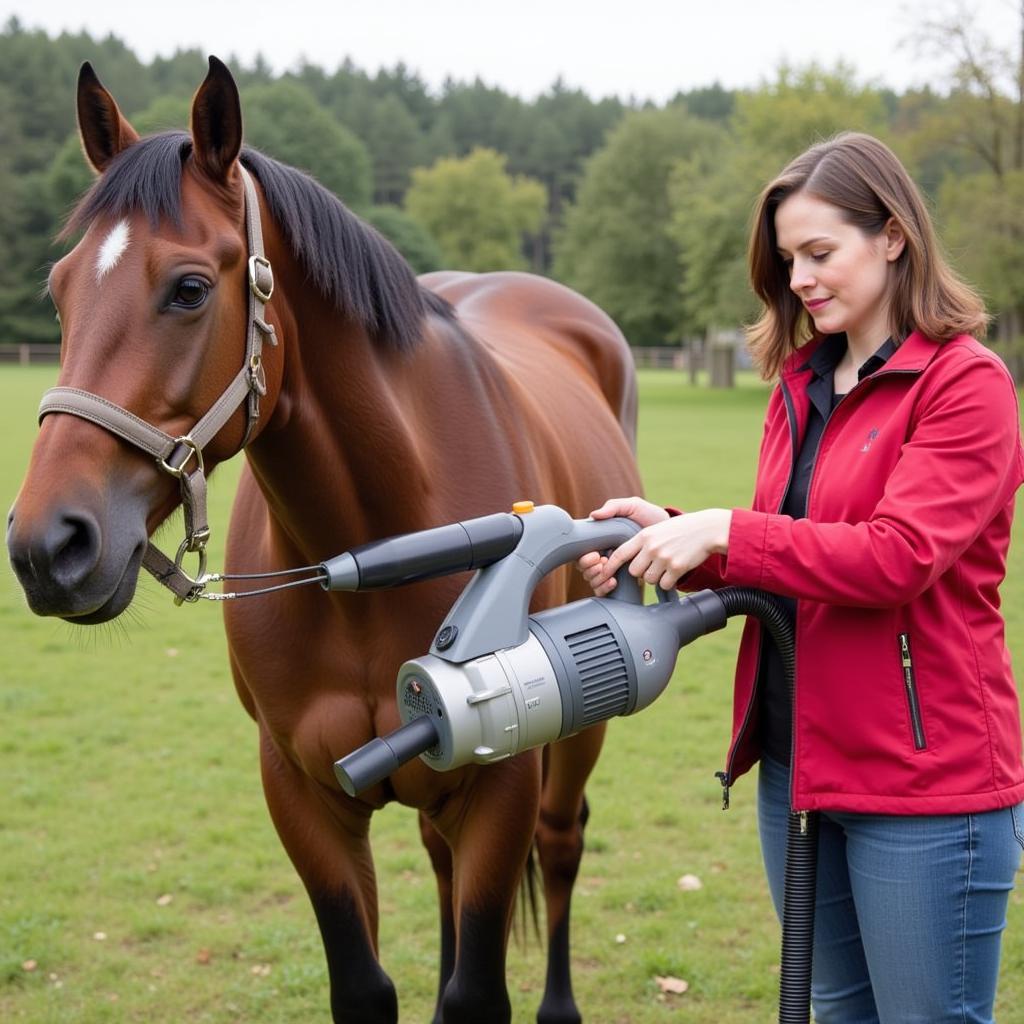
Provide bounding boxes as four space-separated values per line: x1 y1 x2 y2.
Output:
577 498 732 597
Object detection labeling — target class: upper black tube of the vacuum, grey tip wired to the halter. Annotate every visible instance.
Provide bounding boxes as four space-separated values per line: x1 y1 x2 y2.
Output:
321 512 522 591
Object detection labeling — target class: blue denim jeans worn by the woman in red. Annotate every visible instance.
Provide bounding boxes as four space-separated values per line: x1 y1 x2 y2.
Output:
758 758 1024 1024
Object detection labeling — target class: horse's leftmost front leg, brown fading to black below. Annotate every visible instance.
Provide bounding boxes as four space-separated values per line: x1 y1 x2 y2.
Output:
260 728 398 1024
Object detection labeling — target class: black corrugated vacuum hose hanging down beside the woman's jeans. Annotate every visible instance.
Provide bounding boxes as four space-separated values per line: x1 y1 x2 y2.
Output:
716 587 818 1024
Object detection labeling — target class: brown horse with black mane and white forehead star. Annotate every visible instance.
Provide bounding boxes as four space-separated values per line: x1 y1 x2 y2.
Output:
7 58 639 1024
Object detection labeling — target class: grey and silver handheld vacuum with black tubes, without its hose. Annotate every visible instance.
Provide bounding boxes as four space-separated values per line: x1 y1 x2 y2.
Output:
323 505 727 796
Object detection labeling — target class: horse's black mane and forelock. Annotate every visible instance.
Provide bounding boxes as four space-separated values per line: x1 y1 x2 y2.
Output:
61 131 455 351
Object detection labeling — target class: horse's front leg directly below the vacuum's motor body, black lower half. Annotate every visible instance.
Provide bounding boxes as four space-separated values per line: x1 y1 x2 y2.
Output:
435 752 541 1024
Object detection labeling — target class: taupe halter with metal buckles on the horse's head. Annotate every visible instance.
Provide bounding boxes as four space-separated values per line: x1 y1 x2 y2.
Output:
39 164 278 604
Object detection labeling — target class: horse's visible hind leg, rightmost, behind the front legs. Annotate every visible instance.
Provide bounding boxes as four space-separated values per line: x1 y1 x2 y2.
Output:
537 724 605 1024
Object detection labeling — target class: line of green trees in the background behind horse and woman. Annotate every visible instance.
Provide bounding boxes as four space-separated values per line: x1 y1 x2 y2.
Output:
0 11 1024 379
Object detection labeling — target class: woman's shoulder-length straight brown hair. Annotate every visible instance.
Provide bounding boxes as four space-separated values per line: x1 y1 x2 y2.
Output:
746 132 988 379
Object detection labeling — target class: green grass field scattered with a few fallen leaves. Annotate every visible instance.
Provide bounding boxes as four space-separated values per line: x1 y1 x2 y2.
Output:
0 368 1024 1024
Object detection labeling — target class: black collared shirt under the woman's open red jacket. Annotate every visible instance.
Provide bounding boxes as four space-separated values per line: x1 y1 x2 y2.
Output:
758 334 896 764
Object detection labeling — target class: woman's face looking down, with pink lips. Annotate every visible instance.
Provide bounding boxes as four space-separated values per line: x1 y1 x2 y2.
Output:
775 193 904 358
